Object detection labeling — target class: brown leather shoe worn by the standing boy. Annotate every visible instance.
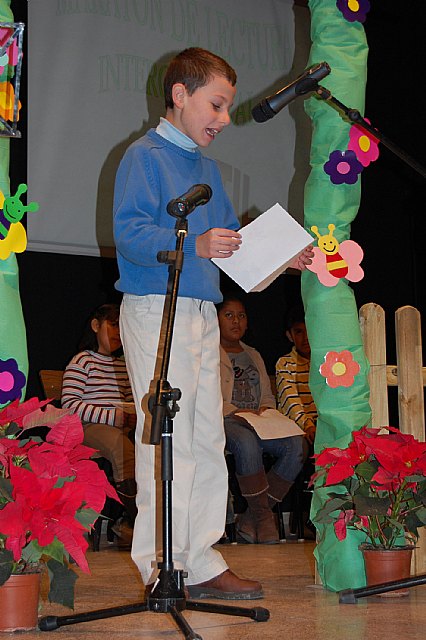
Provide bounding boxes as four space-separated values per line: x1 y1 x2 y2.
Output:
187 569 263 600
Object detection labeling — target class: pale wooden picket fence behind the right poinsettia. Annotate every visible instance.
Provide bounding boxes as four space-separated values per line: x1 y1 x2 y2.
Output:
359 302 426 574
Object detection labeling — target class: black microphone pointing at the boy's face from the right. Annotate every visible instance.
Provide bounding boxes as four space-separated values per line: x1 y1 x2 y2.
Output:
251 62 331 122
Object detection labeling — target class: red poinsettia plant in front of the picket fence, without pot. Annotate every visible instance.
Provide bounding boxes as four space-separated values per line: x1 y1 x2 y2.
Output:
311 427 426 549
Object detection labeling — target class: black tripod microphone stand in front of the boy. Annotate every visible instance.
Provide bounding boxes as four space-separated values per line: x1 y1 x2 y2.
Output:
39 203 269 640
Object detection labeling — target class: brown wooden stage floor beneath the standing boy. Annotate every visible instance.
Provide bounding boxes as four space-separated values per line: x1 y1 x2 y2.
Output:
25 541 426 640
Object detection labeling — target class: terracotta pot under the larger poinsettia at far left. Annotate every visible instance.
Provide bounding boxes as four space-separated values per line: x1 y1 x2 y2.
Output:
0 573 41 632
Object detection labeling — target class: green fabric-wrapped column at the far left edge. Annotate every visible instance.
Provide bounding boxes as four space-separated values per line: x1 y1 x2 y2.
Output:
0 0 28 406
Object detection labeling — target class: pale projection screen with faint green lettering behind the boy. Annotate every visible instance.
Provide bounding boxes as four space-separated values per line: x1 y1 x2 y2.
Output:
26 0 310 255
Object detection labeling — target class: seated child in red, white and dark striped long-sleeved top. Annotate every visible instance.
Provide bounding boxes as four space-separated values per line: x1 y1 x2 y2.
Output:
61 304 136 545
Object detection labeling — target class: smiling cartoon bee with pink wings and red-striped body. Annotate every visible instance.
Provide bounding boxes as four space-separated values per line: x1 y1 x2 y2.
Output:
307 224 364 287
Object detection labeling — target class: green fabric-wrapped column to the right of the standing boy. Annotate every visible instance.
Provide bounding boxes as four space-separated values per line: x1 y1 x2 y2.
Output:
302 0 371 591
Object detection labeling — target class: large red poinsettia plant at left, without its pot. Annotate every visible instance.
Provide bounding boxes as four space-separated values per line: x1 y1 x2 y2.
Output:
0 398 118 607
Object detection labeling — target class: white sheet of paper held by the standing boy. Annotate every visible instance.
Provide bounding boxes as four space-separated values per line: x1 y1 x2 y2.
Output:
212 203 312 293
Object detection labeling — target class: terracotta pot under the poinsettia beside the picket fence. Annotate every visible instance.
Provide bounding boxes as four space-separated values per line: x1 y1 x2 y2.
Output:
362 548 413 598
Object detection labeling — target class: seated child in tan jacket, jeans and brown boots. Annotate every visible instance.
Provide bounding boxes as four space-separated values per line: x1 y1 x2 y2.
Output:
217 296 303 544
